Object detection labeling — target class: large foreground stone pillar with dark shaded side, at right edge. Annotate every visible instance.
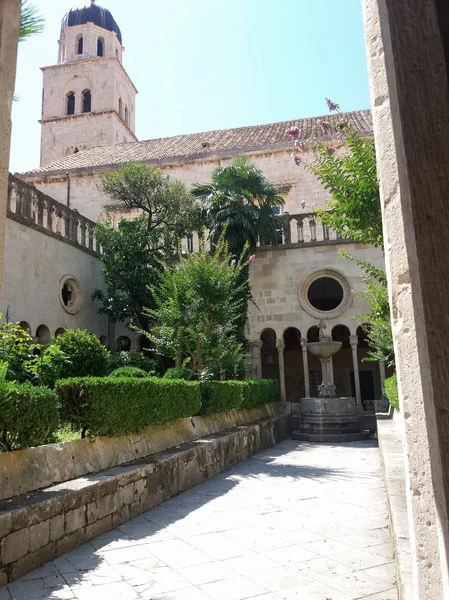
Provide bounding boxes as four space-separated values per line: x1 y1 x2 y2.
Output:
363 0 449 600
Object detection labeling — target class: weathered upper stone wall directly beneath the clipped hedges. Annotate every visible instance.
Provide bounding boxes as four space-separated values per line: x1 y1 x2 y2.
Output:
0 402 286 500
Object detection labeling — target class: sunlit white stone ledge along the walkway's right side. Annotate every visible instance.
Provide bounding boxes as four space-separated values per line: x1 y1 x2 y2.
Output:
377 413 416 600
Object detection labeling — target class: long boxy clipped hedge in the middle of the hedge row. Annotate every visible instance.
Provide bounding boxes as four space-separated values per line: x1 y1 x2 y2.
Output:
56 377 201 435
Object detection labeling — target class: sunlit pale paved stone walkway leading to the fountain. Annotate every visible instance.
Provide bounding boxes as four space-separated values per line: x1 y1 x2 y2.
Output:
0 440 397 600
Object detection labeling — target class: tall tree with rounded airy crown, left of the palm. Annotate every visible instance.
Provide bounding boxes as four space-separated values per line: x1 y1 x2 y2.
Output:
93 164 198 330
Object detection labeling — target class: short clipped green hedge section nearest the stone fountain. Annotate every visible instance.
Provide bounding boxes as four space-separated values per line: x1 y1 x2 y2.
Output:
200 379 279 414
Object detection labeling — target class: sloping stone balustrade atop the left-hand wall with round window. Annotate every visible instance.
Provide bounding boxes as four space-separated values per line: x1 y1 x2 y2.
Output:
7 175 101 254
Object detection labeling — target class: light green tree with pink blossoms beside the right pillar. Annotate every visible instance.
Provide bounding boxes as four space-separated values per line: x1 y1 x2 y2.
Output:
286 100 394 364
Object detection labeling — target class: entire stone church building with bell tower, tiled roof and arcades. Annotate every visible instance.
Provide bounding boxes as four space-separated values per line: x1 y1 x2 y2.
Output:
5 2 385 407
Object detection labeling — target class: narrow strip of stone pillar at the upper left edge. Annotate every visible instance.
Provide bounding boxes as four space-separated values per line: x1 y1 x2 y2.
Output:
0 0 21 300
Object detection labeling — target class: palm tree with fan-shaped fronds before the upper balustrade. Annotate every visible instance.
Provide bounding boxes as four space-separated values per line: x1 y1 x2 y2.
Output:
192 156 284 257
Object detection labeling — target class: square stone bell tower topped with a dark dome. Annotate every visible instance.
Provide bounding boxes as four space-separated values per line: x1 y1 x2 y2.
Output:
40 0 137 166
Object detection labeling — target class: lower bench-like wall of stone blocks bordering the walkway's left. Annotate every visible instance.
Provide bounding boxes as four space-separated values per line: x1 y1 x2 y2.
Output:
0 412 291 585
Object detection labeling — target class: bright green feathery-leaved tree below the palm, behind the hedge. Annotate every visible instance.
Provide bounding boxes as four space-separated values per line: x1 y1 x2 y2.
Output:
146 240 245 379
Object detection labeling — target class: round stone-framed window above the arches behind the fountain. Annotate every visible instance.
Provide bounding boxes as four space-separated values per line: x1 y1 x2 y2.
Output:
298 269 351 318
